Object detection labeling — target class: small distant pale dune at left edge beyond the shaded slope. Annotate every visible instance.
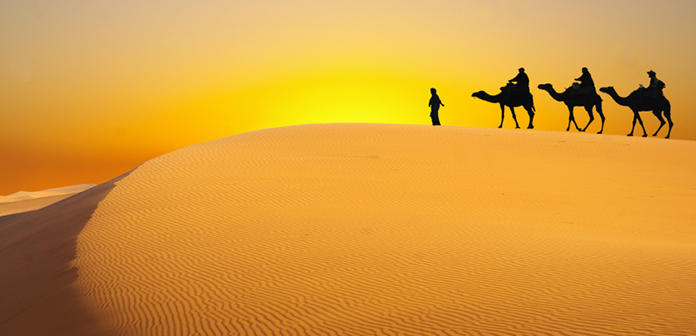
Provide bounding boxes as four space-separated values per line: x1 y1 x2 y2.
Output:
0 184 95 216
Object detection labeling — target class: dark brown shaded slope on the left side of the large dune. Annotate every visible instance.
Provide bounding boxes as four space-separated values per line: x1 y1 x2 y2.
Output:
0 175 125 336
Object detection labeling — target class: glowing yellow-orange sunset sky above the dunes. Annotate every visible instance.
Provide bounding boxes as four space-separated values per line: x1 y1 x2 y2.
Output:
0 0 696 195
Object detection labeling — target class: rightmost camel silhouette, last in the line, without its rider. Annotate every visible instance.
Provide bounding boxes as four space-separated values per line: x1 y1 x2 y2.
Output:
599 86 674 139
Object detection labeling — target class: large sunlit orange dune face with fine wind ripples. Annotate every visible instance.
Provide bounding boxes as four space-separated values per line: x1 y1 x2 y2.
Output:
76 124 696 335
